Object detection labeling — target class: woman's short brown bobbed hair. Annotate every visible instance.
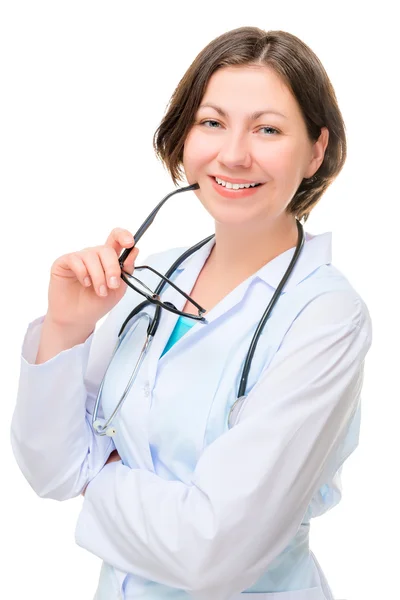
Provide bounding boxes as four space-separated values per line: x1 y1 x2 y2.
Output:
153 27 347 221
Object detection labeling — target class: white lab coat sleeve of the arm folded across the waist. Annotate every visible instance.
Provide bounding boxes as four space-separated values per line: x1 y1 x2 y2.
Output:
75 292 371 600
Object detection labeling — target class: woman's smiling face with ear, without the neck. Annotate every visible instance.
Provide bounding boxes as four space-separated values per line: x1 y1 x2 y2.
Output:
183 66 328 230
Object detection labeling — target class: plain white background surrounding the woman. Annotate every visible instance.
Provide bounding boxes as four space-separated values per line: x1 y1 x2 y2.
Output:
0 0 400 600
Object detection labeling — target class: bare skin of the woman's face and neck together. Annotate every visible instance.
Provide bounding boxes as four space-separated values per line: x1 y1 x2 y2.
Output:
183 65 329 288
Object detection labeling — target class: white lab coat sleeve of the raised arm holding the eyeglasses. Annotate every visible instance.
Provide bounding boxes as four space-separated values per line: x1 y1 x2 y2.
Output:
11 250 167 500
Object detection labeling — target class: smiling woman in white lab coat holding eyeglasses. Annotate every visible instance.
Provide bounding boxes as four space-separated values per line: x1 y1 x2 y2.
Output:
12 27 371 600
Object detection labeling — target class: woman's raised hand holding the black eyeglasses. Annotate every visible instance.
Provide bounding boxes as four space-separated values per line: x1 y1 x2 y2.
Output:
46 228 139 331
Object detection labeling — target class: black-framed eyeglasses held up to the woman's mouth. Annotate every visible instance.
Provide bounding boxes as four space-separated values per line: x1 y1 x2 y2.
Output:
119 183 206 321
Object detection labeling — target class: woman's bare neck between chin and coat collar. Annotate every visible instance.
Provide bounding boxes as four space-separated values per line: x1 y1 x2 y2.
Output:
207 215 298 280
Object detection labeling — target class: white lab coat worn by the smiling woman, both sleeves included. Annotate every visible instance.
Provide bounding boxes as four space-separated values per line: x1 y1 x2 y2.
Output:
11 233 371 600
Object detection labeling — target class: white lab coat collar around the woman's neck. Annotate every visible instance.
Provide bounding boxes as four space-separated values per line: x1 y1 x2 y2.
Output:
173 231 332 292
